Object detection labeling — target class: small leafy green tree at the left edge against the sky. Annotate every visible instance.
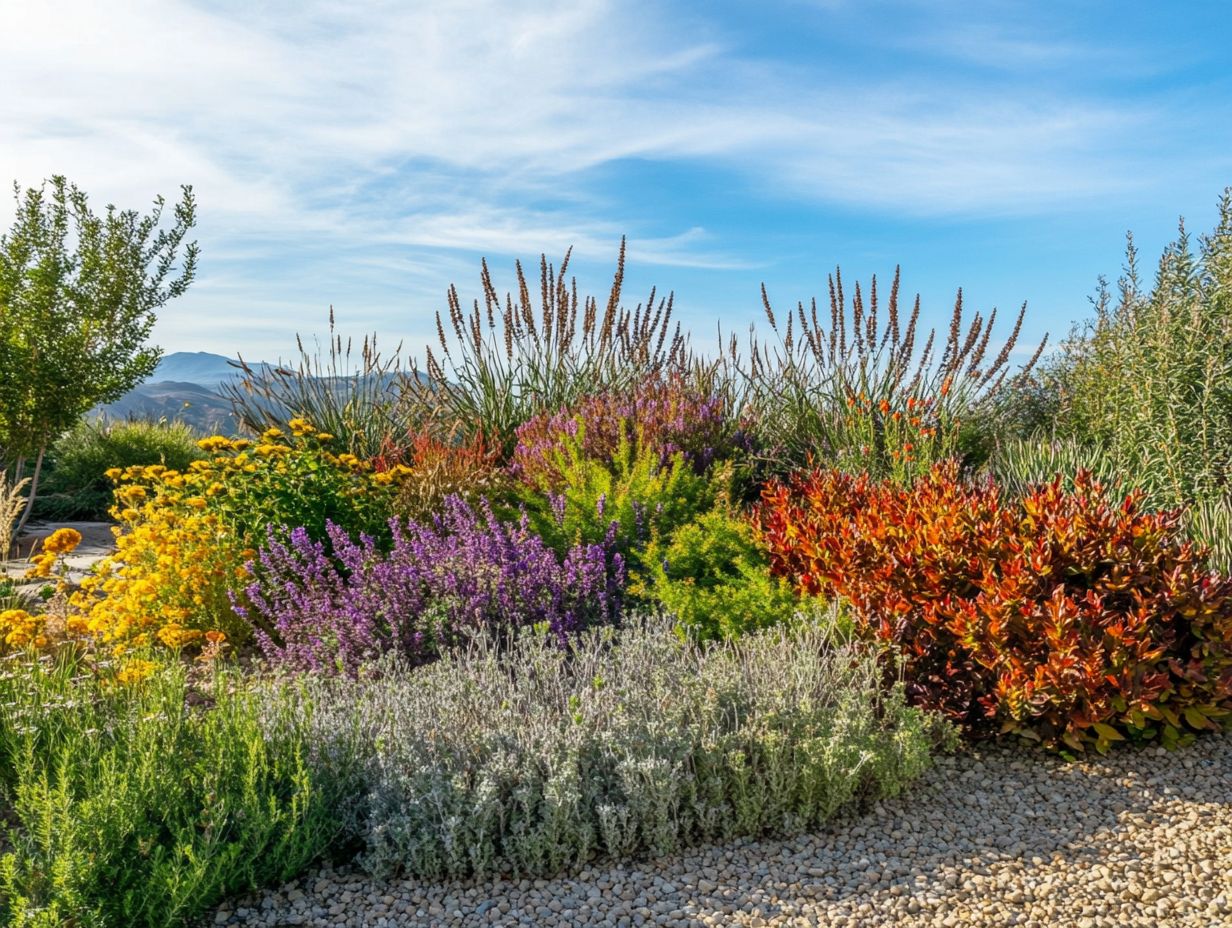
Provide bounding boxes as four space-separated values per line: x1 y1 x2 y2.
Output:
0 175 197 531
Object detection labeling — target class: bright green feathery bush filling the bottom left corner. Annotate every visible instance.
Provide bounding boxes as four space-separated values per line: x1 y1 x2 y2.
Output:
0 659 339 928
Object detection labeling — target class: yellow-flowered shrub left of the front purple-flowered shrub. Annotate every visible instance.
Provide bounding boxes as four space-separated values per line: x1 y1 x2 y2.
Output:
73 419 404 651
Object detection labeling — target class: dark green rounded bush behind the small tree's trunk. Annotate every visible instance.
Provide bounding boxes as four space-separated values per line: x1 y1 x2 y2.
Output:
36 420 205 521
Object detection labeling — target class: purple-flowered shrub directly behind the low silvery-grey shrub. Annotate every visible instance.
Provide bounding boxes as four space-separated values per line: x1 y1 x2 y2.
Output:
235 497 625 674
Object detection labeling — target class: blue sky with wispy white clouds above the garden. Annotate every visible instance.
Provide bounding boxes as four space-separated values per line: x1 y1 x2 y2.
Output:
0 0 1232 360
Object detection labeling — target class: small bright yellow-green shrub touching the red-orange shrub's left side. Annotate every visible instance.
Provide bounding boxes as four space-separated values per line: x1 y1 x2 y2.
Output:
644 507 800 638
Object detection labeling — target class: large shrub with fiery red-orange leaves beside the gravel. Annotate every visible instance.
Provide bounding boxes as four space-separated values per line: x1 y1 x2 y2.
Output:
760 463 1232 749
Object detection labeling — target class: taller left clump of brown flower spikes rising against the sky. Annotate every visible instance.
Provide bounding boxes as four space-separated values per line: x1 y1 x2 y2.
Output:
402 240 690 455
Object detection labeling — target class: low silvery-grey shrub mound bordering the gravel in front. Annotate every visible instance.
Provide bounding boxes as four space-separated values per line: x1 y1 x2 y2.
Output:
279 620 942 880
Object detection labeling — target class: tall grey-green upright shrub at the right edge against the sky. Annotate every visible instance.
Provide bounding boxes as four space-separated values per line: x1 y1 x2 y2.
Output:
1048 187 1232 505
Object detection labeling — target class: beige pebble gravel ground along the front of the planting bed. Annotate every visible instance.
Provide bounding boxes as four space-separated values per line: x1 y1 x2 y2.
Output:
214 735 1232 928
